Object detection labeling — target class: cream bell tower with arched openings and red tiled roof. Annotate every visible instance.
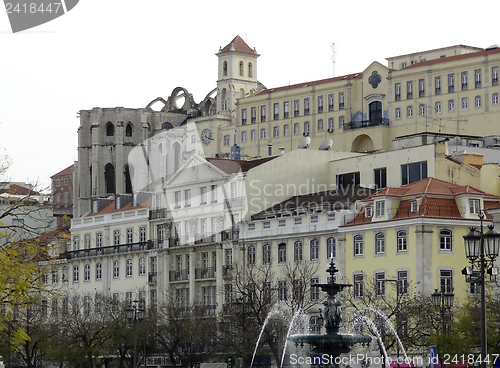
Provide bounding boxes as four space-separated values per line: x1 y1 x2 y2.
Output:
216 36 260 117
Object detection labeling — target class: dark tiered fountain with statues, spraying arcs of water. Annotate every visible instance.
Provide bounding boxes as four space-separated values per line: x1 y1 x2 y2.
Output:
288 259 372 358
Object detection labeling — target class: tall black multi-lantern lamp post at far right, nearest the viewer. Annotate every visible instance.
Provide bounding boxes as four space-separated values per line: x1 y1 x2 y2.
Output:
462 210 500 368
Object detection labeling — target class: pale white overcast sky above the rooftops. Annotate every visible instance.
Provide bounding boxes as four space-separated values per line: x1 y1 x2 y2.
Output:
0 0 500 185
